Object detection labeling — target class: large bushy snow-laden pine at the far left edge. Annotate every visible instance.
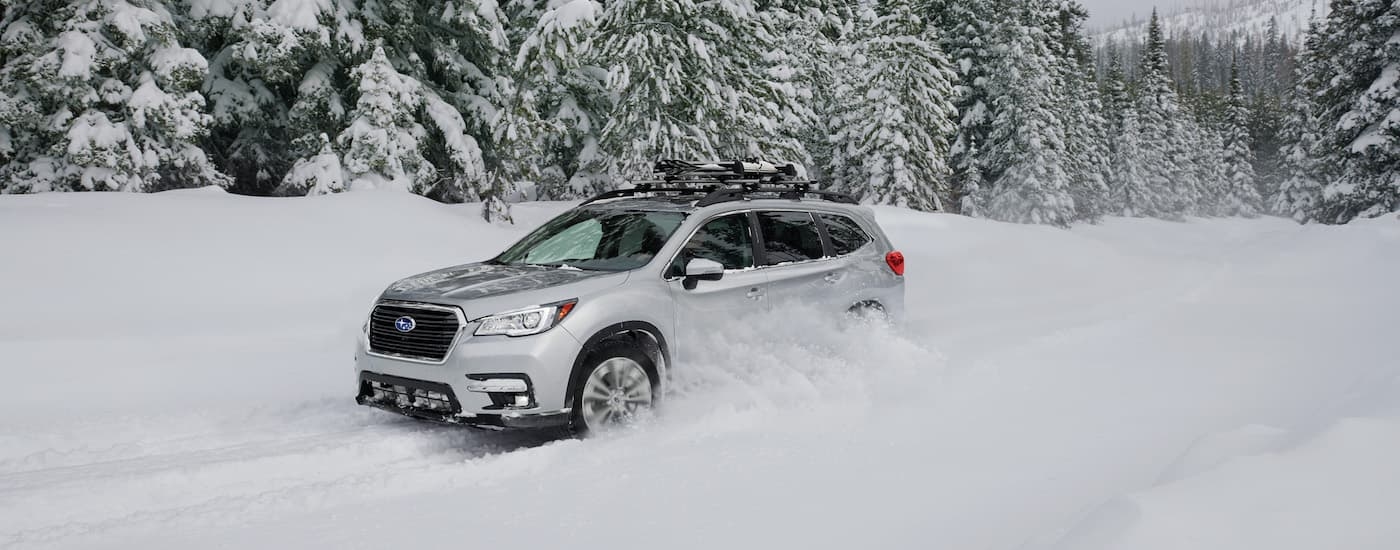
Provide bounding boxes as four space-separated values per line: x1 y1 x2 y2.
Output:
0 0 228 193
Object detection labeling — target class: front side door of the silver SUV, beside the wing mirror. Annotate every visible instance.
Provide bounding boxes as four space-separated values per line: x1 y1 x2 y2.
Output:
666 213 769 357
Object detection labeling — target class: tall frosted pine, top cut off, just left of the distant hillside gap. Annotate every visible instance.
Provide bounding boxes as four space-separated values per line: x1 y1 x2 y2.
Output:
981 0 1075 227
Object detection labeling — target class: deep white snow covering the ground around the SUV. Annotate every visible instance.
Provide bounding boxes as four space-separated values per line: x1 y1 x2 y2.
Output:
0 190 1400 550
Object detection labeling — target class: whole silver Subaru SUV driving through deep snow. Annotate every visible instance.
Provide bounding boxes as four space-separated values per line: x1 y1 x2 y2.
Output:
356 161 904 431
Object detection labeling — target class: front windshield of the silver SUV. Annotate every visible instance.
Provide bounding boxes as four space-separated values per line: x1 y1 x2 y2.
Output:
493 209 686 272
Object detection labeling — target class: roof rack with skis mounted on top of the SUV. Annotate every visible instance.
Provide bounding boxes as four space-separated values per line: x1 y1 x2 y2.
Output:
584 160 860 207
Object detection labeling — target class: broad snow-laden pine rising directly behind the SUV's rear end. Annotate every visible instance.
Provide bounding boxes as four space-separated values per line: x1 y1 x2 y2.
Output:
827 0 955 210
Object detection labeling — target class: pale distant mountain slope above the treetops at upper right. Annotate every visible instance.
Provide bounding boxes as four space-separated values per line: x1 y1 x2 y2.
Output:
1095 0 1327 42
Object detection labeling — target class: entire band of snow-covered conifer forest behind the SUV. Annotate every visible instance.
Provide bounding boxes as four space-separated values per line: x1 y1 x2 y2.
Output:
0 0 1400 225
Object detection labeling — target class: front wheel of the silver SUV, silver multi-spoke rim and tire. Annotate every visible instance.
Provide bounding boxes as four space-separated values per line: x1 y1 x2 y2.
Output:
571 344 659 435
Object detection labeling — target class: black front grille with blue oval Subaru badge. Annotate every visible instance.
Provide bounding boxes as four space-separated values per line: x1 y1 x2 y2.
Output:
370 304 461 362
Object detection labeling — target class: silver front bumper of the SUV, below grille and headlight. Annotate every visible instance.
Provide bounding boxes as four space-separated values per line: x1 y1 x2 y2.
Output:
356 314 582 428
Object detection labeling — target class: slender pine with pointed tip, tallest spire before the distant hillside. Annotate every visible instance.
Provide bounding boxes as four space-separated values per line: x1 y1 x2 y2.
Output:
1131 10 1189 217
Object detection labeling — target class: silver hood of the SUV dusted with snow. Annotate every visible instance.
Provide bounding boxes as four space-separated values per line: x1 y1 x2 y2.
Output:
384 263 627 316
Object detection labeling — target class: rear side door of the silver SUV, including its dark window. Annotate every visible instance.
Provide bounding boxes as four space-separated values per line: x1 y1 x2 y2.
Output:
755 210 841 315
